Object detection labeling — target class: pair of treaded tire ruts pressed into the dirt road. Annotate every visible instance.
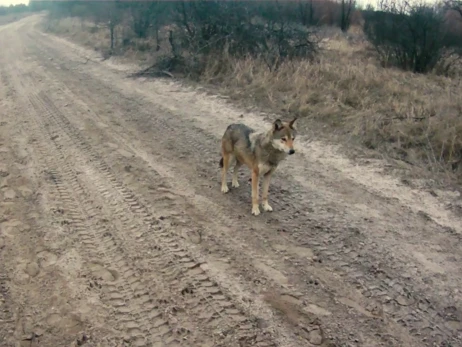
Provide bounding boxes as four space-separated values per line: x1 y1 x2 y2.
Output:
7 64 280 346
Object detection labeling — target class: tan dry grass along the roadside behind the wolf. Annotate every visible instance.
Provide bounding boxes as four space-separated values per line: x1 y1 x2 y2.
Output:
48 19 462 182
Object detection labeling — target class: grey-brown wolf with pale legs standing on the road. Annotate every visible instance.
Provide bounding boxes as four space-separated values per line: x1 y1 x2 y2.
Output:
220 118 297 216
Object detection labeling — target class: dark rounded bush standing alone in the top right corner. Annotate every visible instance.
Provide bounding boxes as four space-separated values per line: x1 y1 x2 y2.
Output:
363 2 462 73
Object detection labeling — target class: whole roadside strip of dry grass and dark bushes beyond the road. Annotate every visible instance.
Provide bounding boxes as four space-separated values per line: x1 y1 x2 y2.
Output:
26 0 462 177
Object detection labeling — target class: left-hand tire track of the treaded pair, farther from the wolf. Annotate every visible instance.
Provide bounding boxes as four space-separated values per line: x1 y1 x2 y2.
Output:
14 89 162 346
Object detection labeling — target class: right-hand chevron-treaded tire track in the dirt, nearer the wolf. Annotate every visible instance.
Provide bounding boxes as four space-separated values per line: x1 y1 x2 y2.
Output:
29 91 274 346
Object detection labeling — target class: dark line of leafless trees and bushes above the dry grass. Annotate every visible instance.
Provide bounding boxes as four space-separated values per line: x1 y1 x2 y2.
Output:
29 0 462 74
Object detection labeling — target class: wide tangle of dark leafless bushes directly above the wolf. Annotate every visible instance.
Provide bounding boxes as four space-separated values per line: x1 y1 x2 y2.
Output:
162 1 317 74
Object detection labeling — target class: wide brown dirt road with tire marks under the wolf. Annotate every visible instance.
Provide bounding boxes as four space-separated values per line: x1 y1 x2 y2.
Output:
0 16 462 347
